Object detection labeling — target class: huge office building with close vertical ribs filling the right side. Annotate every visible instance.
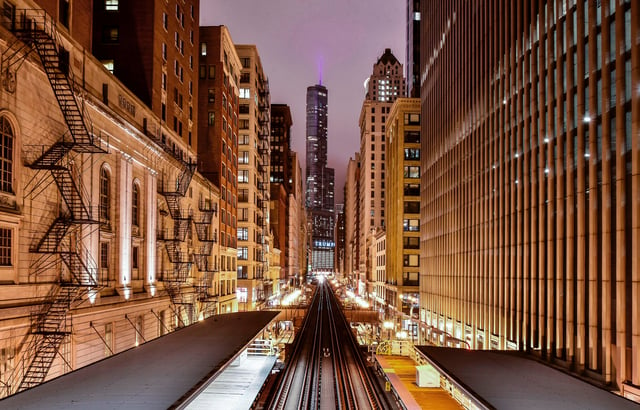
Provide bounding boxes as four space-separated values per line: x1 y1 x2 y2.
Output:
420 0 640 400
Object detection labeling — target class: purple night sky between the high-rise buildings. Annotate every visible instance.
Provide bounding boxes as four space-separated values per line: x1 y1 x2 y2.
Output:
200 0 406 203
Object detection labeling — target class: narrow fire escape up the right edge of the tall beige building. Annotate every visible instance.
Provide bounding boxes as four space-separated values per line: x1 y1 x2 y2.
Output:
258 79 273 298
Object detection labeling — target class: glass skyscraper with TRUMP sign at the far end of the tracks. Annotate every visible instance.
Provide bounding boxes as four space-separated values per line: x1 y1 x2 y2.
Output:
306 84 335 271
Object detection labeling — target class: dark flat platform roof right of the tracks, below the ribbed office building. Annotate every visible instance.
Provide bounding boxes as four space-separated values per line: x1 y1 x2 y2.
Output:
418 346 640 410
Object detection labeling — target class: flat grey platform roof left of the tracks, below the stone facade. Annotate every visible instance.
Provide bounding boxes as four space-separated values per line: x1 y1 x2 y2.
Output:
0 311 279 410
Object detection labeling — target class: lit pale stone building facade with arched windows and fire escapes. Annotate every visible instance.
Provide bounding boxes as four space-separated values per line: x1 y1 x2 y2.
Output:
0 1 220 395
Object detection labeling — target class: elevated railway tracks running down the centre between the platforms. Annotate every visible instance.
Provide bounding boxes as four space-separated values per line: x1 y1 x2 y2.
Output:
266 283 394 410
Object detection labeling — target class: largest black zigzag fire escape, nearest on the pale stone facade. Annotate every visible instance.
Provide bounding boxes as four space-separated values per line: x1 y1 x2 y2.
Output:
2 10 107 394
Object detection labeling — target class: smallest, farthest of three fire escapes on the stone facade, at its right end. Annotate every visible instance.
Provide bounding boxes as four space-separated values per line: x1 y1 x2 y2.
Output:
193 199 219 317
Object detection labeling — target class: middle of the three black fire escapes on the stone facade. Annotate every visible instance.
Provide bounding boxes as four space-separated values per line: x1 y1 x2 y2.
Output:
157 156 196 326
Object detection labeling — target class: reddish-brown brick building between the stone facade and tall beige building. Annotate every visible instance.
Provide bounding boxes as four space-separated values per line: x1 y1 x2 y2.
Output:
197 26 242 312
